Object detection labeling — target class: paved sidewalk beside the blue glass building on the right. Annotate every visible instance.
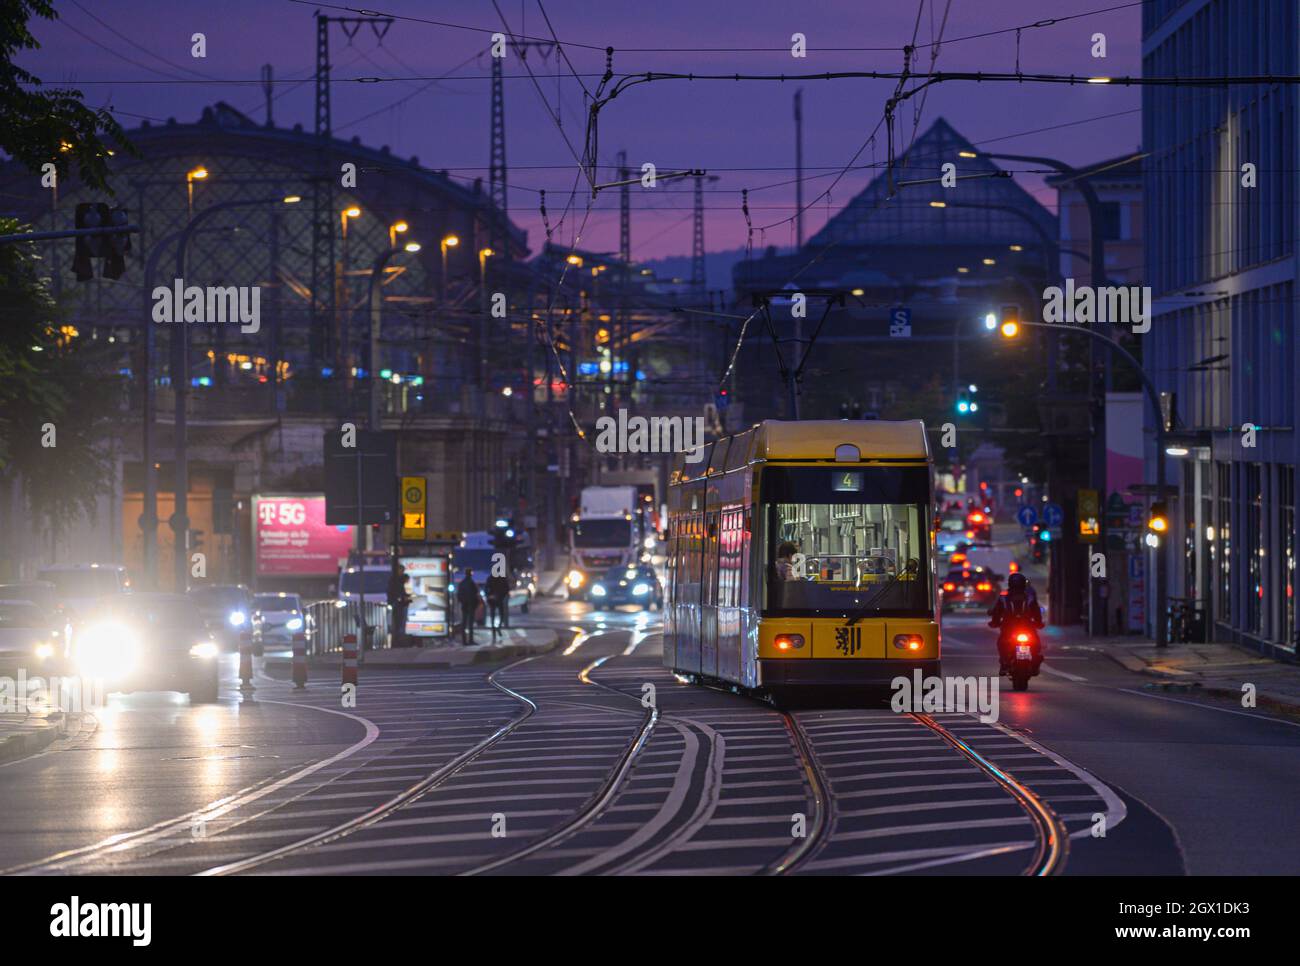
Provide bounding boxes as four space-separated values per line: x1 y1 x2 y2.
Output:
1047 628 1300 714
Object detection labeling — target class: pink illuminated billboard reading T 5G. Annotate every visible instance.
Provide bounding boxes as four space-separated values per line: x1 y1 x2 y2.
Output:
252 493 355 577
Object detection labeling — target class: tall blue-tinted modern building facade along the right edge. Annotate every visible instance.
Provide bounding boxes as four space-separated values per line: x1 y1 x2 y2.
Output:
1143 0 1300 659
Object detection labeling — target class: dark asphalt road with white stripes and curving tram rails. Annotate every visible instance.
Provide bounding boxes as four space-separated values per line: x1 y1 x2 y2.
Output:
0 602 1300 875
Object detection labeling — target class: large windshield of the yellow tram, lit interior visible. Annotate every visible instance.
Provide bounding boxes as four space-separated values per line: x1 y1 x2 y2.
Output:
761 467 932 618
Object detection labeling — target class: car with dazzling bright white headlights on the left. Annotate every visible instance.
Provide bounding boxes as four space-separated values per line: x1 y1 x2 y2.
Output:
70 593 220 702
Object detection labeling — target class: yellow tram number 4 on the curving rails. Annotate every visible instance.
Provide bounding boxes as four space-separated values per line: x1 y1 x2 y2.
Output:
663 420 940 693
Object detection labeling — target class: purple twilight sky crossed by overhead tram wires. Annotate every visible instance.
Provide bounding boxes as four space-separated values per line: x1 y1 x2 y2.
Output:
21 0 1141 260
